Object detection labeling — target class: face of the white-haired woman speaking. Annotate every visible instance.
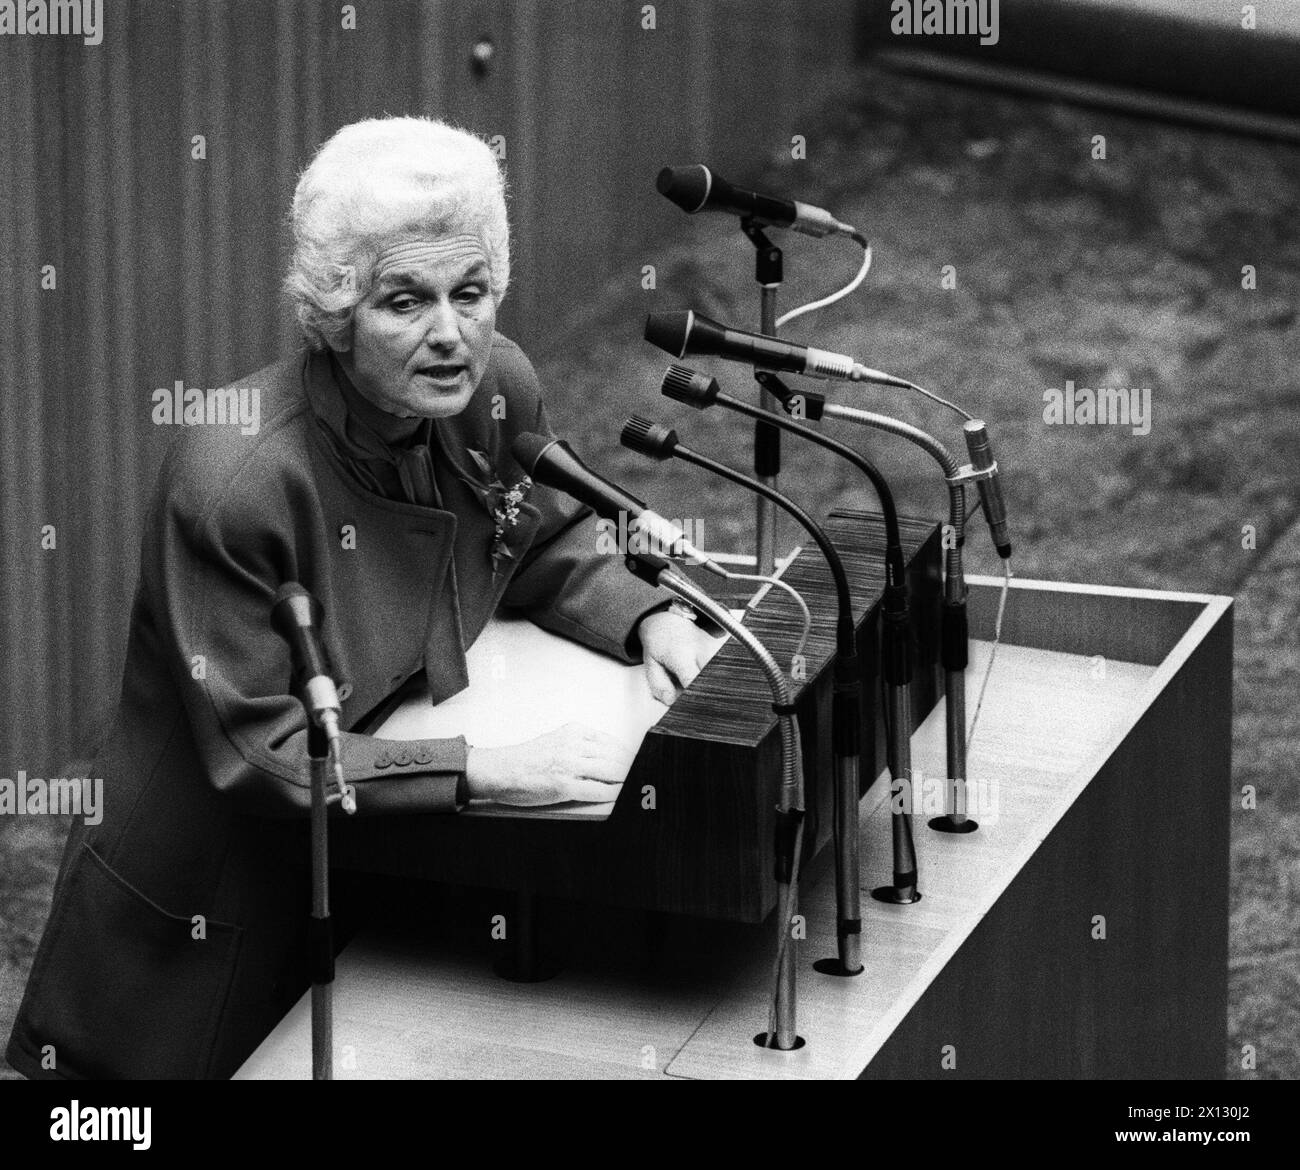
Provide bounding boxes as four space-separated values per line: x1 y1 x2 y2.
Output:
338 234 497 419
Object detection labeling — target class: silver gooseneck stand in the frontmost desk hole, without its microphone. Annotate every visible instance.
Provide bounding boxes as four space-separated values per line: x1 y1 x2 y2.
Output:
625 553 805 1052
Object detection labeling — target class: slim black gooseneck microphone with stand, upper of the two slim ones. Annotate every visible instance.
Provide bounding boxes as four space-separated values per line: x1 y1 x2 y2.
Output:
662 365 920 905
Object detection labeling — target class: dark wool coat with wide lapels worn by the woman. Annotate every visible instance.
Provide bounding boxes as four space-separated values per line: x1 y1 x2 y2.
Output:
7 337 666 1078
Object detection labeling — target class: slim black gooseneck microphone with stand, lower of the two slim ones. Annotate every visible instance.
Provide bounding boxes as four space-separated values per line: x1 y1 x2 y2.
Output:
621 417 863 975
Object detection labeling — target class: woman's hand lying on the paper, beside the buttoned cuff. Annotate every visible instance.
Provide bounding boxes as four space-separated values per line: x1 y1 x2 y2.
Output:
465 723 632 805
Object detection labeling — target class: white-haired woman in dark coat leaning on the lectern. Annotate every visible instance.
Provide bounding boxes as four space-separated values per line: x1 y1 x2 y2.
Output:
7 118 707 1078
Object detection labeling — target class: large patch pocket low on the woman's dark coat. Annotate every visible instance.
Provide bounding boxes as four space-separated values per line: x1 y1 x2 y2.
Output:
20 844 242 1080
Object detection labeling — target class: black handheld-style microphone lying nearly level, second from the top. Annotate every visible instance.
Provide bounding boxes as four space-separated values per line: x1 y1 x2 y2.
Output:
645 309 910 390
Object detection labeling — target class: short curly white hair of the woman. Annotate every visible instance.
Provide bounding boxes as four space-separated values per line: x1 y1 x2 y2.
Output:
285 117 510 350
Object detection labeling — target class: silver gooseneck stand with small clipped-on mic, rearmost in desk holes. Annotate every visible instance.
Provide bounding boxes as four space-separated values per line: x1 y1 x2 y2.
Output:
759 374 979 833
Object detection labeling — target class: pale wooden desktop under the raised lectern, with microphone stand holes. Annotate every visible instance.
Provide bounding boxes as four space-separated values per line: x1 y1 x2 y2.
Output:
238 642 1169 1079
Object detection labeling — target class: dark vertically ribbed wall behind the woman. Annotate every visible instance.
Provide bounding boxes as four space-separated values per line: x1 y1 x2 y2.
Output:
0 0 854 775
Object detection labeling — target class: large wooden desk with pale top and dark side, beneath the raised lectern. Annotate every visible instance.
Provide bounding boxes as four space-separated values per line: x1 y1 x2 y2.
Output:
238 561 1232 1079
